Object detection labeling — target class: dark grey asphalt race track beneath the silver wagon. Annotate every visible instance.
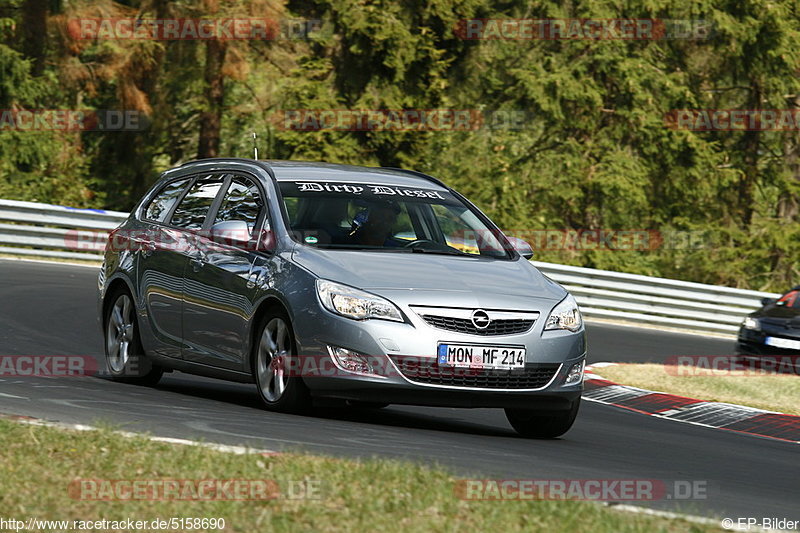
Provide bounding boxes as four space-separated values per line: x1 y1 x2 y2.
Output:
0 260 800 520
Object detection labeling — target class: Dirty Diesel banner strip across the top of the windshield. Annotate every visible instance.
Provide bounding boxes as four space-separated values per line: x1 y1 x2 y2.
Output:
280 181 460 204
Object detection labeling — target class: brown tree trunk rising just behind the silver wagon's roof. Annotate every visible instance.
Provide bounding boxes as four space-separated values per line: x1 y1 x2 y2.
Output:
197 39 227 159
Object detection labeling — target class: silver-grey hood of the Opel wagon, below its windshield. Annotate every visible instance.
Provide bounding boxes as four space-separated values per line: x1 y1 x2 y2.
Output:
293 246 567 301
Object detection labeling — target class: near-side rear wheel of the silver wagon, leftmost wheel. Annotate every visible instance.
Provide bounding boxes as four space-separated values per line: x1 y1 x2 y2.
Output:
104 289 164 387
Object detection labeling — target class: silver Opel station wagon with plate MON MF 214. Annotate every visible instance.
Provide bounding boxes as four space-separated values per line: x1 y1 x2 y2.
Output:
98 159 586 438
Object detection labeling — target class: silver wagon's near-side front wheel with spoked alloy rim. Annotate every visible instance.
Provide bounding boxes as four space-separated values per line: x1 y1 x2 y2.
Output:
253 309 312 413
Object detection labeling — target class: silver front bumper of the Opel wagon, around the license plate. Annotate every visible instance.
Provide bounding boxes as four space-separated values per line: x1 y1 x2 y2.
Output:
294 294 586 412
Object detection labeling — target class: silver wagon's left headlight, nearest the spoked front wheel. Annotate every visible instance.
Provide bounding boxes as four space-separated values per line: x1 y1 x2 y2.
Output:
317 279 403 322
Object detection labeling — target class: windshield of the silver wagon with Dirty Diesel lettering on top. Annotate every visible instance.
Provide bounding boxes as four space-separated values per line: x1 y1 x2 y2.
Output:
280 181 511 259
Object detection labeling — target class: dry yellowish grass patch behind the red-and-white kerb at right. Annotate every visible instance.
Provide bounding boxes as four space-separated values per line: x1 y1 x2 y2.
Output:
594 363 800 415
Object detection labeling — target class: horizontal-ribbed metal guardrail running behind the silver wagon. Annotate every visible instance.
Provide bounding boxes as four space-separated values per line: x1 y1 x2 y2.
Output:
0 200 778 334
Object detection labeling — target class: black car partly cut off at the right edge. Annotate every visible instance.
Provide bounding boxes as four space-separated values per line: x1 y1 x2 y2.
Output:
736 285 800 364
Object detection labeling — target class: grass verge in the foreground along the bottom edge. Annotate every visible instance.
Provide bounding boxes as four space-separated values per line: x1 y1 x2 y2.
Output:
0 419 717 533
